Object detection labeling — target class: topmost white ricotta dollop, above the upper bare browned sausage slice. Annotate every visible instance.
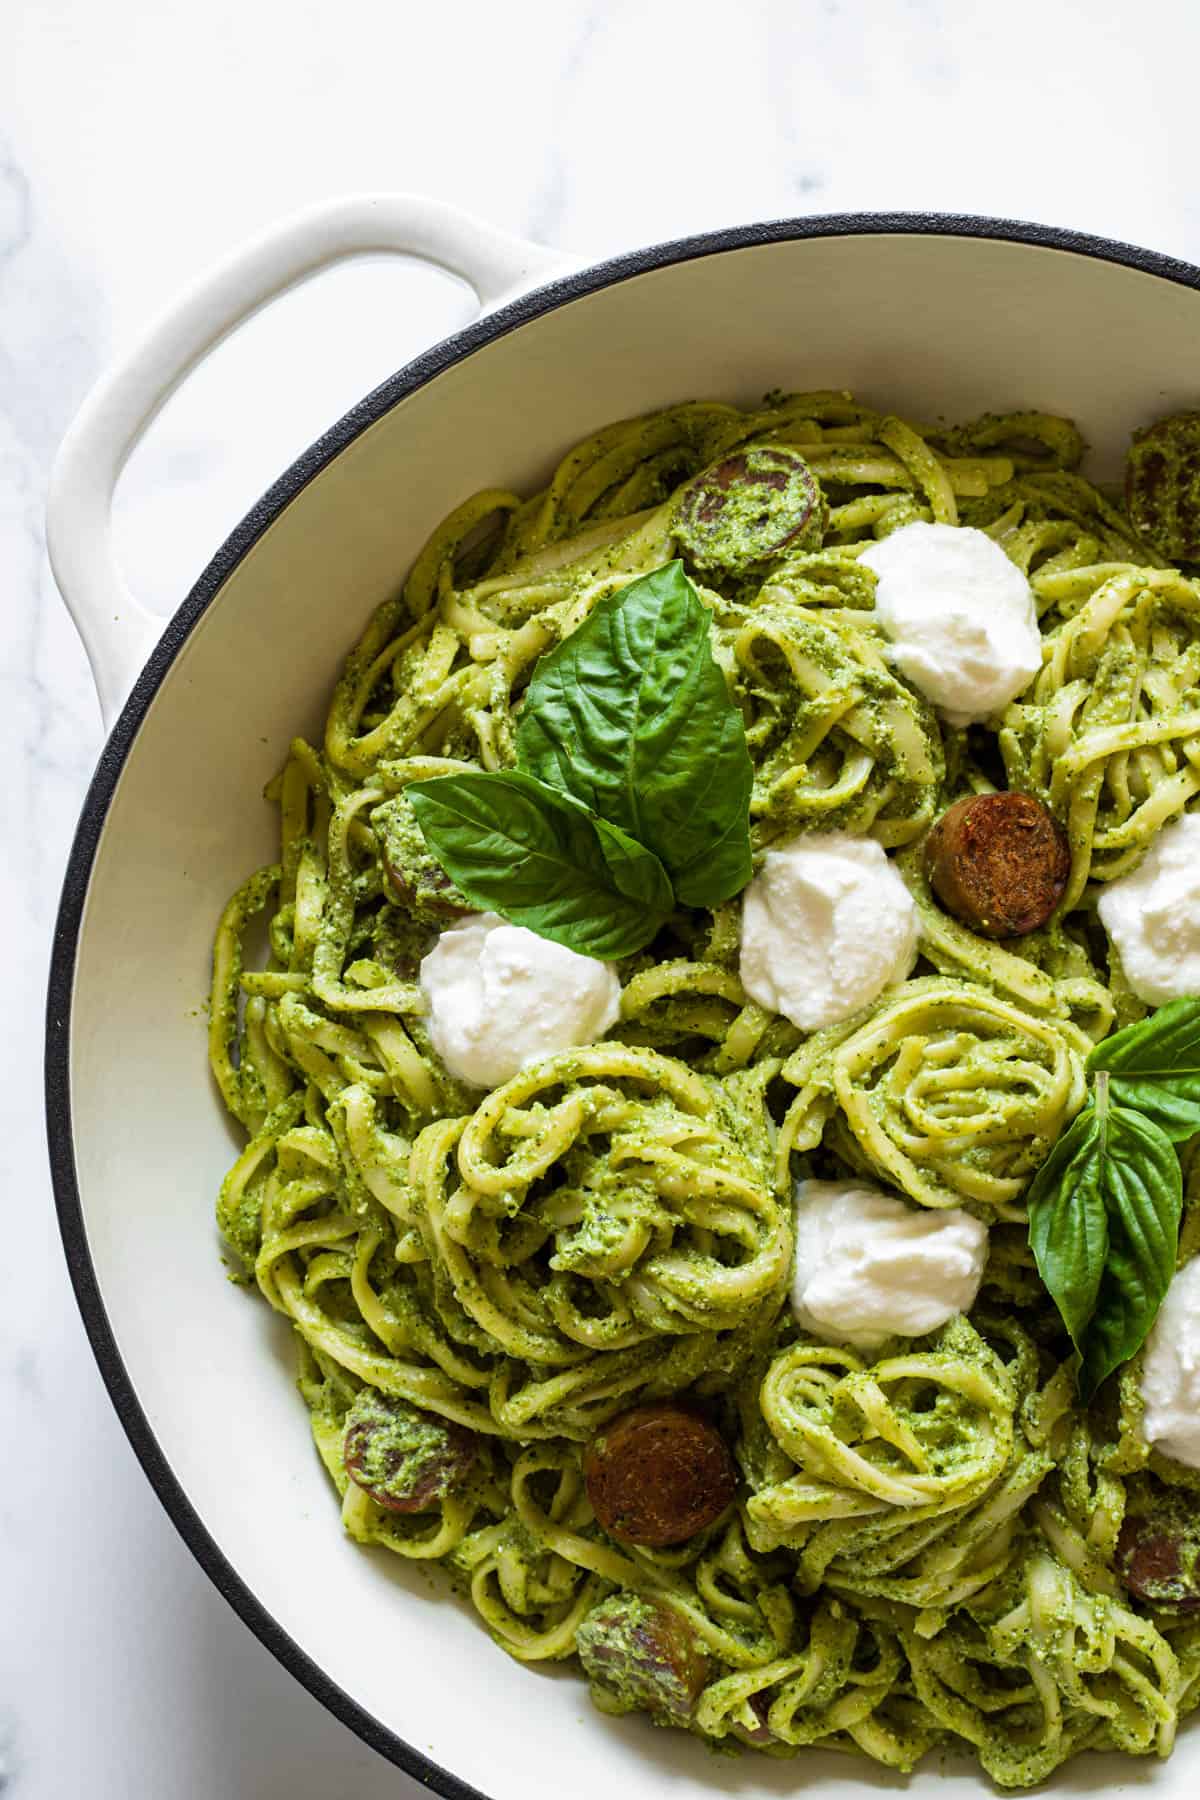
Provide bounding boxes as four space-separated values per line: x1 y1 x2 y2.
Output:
858 520 1042 725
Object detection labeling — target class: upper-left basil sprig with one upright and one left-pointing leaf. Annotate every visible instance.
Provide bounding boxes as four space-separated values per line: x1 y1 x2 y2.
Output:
407 562 754 959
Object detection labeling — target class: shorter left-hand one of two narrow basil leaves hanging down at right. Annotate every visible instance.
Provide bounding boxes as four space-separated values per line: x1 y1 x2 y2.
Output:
1027 1107 1108 1350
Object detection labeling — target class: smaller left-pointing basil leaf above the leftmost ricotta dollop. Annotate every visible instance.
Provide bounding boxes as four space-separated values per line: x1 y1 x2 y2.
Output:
405 770 673 961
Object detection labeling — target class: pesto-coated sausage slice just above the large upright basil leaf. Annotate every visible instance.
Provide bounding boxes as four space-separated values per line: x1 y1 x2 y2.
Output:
675 445 829 574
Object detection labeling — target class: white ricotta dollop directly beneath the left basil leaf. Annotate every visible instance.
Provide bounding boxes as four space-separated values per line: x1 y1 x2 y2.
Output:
421 913 621 1087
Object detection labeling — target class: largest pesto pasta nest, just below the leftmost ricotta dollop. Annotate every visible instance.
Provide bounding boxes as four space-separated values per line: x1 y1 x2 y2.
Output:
410 1044 792 1408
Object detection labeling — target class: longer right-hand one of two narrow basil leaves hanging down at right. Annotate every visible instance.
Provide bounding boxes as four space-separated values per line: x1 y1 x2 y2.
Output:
1079 1103 1184 1400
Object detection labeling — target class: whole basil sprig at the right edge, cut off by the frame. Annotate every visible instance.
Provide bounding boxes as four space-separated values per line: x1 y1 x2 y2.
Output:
1027 999 1200 1399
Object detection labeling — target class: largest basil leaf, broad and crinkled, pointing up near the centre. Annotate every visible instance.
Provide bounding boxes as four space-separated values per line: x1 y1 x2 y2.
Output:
516 562 754 905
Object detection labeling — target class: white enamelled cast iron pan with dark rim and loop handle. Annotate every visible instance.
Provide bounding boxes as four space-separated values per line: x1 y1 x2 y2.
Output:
47 196 1200 1800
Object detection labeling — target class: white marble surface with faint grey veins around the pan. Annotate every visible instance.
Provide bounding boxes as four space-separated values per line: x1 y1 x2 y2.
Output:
0 0 1200 1800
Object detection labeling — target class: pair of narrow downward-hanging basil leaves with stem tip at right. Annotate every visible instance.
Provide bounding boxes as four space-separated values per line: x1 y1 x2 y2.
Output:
1027 1075 1184 1399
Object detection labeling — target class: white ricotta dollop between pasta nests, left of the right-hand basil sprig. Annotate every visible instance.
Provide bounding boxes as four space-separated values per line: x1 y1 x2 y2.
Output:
792 1181 988 1350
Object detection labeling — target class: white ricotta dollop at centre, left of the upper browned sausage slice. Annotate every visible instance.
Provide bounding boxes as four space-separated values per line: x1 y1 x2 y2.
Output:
739 833 918 1031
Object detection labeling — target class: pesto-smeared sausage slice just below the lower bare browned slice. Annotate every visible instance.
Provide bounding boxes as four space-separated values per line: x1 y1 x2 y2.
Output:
576 1589 712 1724
